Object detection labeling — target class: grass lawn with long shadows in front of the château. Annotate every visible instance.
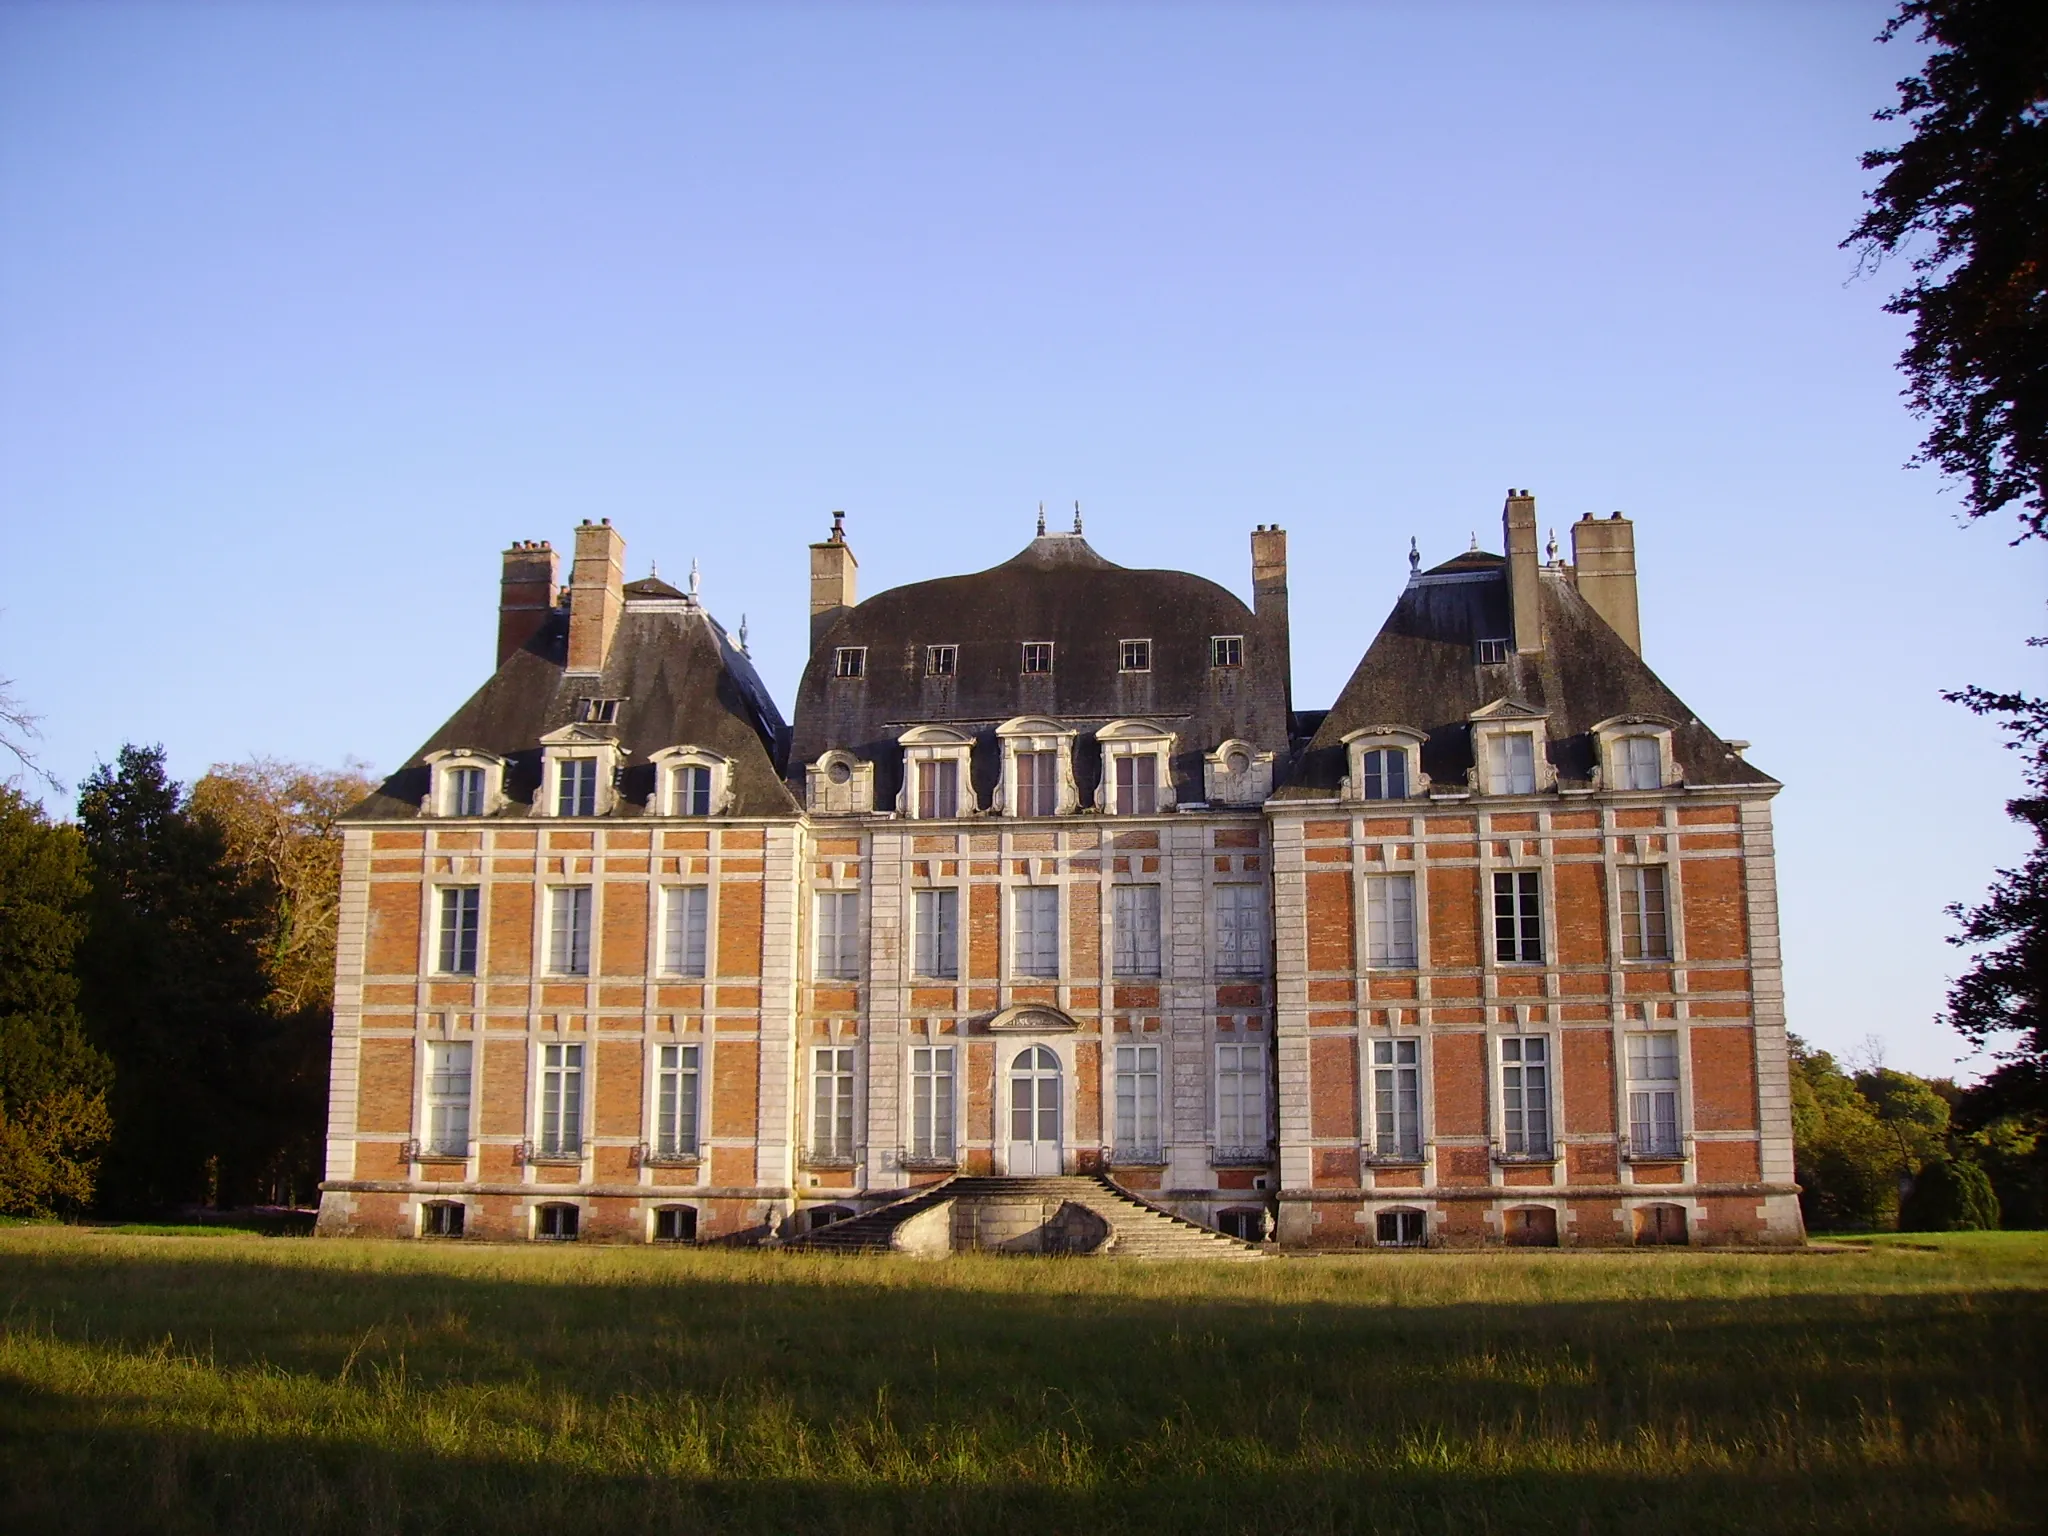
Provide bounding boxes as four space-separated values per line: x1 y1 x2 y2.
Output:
0 1227 2048 1536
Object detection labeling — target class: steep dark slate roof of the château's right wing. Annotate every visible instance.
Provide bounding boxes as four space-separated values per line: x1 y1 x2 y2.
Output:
1276 551 1778 799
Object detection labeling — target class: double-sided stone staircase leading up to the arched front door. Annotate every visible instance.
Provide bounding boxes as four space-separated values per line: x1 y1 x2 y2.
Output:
784 1174 1266 1264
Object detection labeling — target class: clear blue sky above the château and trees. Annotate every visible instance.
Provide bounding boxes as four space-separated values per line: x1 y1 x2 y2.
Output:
0 0 2048 1071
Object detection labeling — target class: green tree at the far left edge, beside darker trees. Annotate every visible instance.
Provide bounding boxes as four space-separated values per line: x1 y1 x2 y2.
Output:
0 786 109 1214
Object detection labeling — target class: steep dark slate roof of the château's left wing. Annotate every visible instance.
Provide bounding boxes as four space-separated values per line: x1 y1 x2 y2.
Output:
350 593 797 821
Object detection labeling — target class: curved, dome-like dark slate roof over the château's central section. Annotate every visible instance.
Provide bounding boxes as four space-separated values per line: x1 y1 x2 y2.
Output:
788 532 1288 807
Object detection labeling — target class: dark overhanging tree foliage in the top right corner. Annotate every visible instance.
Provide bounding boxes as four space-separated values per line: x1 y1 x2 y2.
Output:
1843 0 2048 539
